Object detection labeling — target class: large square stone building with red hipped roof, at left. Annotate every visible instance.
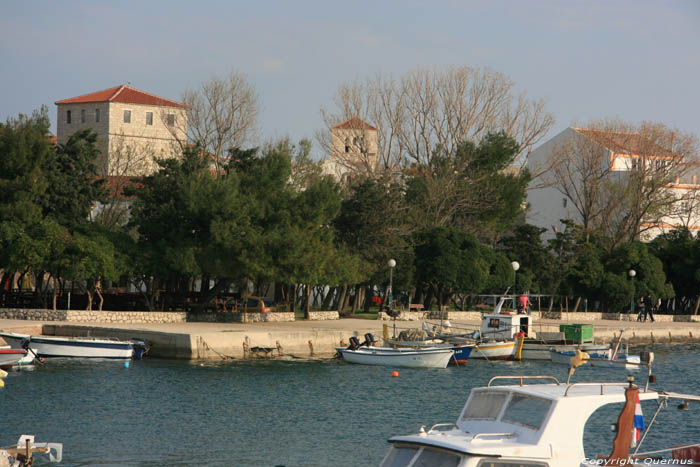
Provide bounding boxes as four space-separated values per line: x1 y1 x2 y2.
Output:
56 85 187 177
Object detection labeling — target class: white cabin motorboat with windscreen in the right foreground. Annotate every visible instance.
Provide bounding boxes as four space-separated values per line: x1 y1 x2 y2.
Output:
381 376 700 467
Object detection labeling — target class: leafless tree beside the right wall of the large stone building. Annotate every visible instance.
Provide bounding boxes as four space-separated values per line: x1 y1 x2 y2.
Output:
175 71 260 175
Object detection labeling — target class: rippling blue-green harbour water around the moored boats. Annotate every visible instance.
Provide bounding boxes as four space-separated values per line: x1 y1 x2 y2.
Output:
0 344 700 467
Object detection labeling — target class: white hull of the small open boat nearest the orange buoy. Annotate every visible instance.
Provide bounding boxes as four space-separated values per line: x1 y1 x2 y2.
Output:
337 347 454 368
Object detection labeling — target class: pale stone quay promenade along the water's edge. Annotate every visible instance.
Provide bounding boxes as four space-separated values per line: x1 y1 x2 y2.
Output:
0 313 700 360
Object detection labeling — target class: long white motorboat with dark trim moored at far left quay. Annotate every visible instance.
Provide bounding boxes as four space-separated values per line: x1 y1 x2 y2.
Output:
0 332 139 359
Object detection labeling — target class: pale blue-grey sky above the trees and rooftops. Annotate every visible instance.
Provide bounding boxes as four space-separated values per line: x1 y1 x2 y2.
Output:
0 0 700 156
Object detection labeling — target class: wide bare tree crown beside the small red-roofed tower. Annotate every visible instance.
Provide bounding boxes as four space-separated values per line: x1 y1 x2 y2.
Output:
316 66 554 176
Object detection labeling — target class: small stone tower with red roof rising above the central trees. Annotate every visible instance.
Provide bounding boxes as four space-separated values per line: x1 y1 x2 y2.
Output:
323 117 379 180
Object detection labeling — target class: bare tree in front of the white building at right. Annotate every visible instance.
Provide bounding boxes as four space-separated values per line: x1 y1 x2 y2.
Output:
544 120 698 248
